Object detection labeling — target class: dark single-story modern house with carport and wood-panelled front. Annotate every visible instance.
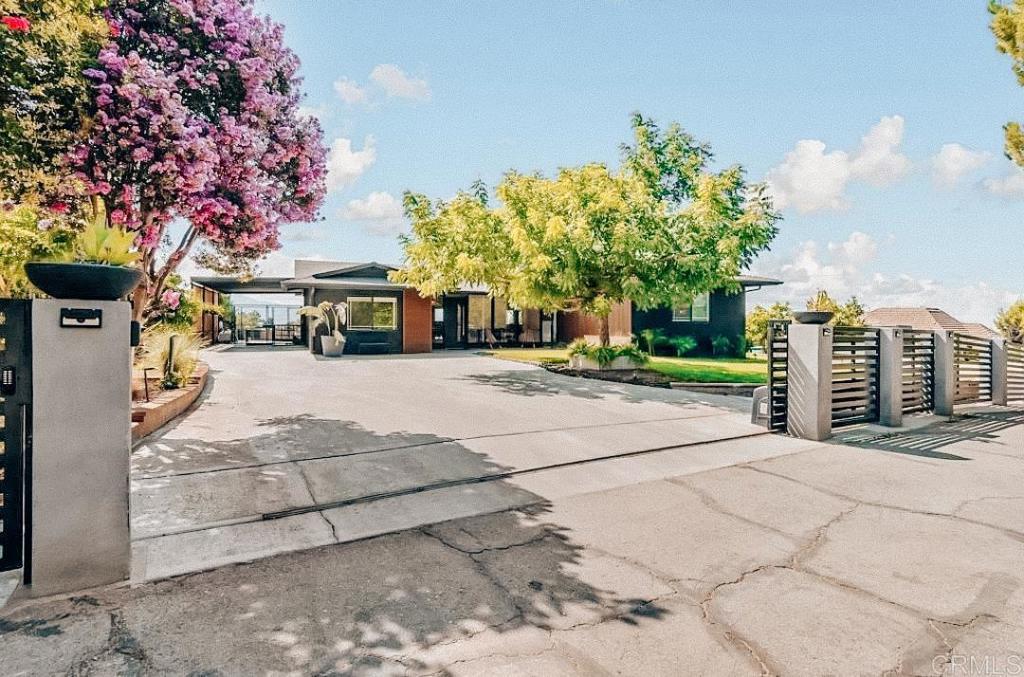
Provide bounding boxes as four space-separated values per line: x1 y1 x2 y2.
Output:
193 260 781 354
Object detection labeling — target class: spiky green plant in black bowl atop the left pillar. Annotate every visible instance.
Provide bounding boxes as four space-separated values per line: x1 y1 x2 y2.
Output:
25 204 142 301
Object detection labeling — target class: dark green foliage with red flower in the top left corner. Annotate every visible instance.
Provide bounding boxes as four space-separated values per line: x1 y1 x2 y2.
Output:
0 0 107 201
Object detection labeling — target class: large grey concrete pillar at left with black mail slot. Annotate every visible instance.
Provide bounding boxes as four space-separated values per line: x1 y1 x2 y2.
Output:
25 299 131 596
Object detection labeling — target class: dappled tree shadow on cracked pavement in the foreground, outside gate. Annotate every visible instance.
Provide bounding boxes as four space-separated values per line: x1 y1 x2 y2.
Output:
0 506 669 675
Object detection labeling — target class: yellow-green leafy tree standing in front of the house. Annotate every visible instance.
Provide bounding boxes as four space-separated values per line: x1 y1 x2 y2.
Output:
393 114 779 345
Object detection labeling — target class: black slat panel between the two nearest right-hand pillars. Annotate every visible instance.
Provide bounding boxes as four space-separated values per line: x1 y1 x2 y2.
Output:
831 327 880 425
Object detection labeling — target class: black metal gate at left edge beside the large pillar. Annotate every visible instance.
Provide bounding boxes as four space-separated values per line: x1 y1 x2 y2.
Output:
0 299 32 572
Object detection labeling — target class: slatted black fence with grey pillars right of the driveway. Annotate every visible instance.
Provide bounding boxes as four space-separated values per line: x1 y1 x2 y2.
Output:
768 323 1024 440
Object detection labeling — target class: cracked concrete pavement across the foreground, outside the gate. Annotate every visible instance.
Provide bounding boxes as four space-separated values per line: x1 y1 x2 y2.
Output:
0 409 1024 676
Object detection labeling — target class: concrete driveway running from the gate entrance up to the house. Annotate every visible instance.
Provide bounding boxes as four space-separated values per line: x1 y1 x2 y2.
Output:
132 348 806 581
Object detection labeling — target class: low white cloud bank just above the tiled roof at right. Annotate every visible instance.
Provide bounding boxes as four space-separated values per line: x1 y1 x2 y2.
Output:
750 231 1021 326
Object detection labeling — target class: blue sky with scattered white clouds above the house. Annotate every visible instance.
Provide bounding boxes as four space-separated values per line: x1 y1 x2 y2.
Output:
230 0 1024 322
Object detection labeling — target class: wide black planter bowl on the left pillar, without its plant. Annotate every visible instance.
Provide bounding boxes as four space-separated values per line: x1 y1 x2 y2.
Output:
25 262 142 301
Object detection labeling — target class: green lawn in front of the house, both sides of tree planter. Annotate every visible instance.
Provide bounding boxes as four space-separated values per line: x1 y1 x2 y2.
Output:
485 348 768 383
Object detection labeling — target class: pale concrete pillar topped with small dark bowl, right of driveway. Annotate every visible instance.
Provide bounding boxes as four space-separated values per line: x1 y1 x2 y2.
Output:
786 324 833 440
